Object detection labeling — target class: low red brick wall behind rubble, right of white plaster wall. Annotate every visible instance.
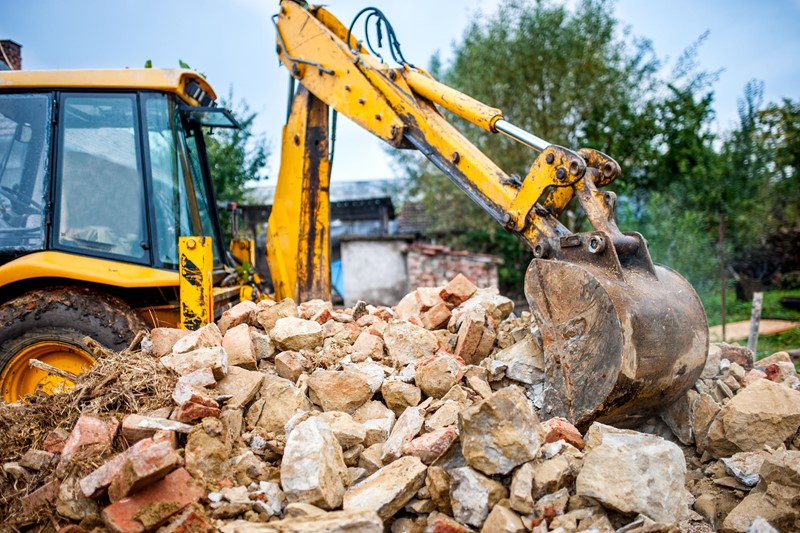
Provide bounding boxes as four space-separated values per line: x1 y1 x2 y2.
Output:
406 244 502 289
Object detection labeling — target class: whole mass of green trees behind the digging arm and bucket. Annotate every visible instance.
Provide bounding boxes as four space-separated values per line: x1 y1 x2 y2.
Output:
396 0 800 315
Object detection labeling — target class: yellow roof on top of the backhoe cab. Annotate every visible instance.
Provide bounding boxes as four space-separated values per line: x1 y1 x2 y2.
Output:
0 68 217 105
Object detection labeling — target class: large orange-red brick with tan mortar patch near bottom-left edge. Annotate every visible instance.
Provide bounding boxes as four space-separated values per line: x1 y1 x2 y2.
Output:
102 468 205 533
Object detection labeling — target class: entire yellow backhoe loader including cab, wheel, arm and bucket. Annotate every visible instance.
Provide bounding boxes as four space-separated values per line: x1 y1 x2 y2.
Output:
0 0 708 427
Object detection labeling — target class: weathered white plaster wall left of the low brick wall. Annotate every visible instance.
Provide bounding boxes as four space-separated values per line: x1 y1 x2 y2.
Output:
341 239 408 306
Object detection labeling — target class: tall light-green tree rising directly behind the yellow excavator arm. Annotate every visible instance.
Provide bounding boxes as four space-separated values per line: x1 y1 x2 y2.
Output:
398 0 659 292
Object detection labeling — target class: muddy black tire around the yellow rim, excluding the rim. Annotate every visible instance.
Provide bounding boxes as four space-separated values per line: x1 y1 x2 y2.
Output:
0 287 147 366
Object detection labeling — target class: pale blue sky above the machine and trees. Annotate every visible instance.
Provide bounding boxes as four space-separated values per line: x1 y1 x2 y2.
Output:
0 0 800 187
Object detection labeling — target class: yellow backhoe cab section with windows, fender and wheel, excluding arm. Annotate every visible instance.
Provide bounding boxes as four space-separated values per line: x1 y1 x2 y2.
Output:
0 69 244 402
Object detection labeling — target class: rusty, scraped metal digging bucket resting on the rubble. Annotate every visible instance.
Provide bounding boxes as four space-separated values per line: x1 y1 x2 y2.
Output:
525 232 708 429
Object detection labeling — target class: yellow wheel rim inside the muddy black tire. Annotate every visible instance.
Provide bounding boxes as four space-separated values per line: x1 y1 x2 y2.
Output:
0 341 94 403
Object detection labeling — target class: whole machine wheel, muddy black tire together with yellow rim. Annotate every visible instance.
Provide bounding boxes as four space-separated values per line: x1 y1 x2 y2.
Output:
0 287 147 403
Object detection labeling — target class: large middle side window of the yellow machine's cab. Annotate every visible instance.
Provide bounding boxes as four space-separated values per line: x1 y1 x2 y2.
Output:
55 93 150 263
